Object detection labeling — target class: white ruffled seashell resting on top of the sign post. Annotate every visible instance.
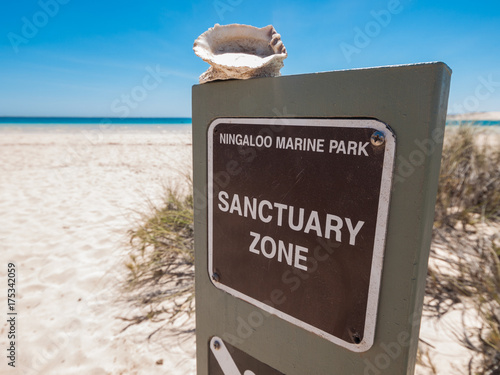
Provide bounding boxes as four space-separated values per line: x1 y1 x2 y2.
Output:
193 24 287 83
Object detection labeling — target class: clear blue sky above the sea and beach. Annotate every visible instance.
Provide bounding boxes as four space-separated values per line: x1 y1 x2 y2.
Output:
0 0 500 117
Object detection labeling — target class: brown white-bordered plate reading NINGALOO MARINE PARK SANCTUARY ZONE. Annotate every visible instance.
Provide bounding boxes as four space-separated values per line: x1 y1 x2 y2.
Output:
208 118 395 352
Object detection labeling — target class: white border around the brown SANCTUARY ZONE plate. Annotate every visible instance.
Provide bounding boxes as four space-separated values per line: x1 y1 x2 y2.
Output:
207 117 396 352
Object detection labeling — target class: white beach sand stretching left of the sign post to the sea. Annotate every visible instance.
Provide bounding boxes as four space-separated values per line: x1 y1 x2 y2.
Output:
0 128 195 375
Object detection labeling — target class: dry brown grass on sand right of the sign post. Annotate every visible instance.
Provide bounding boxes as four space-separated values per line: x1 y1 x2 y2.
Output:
424 127 500 375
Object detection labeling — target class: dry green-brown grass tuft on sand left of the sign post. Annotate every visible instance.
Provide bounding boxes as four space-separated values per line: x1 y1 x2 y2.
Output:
121 189 194 338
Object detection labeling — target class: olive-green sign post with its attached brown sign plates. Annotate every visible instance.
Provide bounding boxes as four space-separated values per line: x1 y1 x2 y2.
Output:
193 63 451 375
